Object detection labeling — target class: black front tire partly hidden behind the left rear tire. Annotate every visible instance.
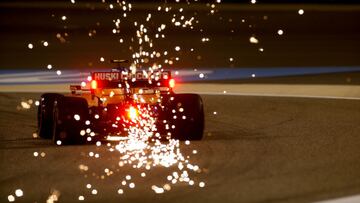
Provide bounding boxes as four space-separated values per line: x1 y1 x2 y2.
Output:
37 93 63 139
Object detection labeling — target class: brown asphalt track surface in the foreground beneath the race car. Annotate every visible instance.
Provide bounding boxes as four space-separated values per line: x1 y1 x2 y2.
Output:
0 93 360 202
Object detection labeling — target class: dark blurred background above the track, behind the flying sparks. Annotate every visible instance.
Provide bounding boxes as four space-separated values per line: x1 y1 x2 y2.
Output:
0 0 360 84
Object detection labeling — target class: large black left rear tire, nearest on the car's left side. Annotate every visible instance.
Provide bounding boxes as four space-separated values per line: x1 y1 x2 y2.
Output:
52 97 89 145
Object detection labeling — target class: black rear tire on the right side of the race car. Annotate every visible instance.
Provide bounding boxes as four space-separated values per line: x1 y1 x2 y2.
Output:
167 94 205 140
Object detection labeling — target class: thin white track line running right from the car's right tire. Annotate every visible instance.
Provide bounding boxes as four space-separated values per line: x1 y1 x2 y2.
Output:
178 92 360 100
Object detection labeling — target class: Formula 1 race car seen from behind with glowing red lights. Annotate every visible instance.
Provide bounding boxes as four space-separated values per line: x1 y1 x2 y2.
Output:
37 60 204 145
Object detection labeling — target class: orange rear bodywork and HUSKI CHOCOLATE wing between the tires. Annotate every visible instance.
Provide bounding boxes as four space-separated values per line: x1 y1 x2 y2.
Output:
70 71 175 107
